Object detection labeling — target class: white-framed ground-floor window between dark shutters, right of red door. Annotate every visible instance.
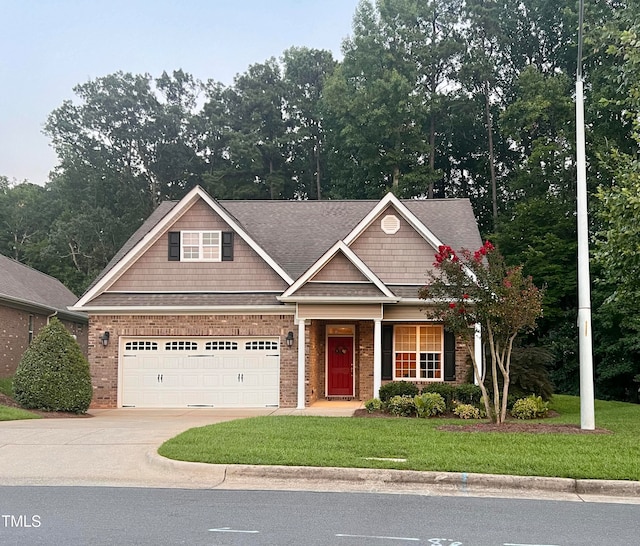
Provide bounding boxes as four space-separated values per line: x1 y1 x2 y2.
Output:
393 324 444 381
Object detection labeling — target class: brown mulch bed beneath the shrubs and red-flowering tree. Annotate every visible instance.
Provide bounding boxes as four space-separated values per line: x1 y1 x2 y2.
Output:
354 409 612 434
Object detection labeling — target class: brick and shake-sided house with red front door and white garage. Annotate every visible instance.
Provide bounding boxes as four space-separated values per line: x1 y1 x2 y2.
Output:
72 187 481 408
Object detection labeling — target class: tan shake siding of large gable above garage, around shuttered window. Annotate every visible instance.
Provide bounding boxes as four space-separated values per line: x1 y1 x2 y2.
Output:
109 200 287 292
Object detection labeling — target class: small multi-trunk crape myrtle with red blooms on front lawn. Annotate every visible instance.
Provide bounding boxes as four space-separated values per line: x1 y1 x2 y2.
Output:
420 241 543 424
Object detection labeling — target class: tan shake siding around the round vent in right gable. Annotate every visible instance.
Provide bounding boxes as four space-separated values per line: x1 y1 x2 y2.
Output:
349 207 435 284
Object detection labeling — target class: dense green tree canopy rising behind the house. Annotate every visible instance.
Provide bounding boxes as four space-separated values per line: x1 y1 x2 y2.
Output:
0 0 640 397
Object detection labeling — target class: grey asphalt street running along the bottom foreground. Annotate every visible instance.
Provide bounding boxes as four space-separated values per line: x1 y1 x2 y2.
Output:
0 487 640 546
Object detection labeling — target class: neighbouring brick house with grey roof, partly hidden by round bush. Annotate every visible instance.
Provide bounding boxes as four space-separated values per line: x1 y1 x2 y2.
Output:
0 255 88 377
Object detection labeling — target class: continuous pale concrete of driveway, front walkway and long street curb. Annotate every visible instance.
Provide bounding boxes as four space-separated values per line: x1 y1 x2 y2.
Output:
0 402 640 504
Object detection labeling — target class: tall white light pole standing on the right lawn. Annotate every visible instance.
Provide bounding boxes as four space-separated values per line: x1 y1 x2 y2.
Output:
576 0 596 430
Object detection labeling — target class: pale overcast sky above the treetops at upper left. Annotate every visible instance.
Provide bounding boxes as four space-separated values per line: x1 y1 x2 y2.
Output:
0 0 358 184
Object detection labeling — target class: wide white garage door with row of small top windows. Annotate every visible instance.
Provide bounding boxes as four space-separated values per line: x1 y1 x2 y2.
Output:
120 337 280 408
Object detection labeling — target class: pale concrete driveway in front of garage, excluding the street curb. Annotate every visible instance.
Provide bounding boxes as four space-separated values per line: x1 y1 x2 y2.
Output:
0 408 336 487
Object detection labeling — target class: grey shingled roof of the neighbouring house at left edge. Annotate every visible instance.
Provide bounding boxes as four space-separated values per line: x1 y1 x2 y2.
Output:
0 254 87 322
